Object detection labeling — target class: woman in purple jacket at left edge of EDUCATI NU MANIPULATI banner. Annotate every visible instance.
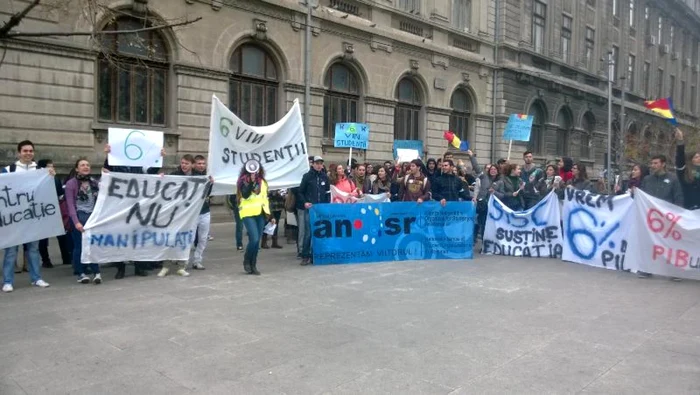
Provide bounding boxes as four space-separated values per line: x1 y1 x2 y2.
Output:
66 158 102 284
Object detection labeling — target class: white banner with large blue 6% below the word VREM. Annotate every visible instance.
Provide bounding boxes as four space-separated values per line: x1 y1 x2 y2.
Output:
562 188 637 271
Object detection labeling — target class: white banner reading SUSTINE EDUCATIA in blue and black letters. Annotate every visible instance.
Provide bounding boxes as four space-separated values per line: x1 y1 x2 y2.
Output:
482 192 562 258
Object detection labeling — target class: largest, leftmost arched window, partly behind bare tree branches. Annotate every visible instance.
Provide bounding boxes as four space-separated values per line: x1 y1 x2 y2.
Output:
97 17 168 126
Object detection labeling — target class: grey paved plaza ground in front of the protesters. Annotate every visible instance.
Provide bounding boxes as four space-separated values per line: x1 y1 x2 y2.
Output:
0 224 700 395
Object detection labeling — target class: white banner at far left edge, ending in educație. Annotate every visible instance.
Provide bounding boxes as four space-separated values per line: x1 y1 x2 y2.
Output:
0 169 65 248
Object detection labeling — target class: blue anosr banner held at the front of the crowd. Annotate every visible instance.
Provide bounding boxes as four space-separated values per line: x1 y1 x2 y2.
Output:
310 202 476 265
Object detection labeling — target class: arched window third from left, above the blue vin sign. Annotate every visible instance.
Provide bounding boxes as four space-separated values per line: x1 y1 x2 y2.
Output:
323 63 360 139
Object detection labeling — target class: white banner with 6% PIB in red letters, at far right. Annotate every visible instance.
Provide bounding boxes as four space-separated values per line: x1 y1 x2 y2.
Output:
627 189 700 280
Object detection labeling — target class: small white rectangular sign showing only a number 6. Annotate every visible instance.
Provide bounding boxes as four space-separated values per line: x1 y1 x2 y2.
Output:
108 128 163 168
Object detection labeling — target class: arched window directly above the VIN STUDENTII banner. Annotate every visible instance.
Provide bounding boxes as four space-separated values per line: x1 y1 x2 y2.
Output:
229 44 279 126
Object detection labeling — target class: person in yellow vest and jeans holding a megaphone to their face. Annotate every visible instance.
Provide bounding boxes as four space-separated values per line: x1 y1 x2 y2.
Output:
237 160 276 275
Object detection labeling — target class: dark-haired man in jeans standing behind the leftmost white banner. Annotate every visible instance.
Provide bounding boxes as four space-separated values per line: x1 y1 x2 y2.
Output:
2 140 51 292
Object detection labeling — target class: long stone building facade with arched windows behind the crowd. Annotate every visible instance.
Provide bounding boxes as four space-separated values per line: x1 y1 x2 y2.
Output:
0 0 700 172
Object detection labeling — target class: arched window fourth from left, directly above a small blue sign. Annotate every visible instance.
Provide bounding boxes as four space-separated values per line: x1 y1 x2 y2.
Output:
394 77 422 140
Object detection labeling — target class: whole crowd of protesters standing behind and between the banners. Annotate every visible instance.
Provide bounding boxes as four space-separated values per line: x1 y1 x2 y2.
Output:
2 129 700 292
